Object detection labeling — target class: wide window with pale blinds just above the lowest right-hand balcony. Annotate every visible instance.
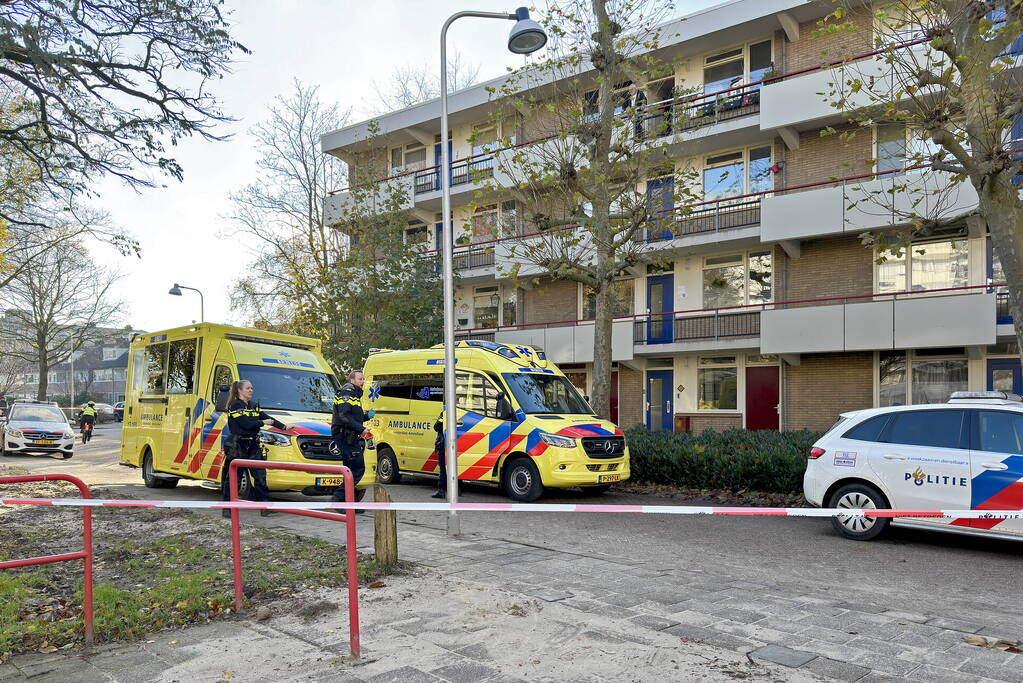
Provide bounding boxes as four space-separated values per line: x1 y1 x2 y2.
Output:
877 239 970 294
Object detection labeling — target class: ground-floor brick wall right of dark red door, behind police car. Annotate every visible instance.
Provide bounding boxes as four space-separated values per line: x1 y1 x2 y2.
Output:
783 352 874 429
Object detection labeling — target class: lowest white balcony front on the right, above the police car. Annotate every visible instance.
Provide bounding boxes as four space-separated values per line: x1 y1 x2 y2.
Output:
760 285 996 354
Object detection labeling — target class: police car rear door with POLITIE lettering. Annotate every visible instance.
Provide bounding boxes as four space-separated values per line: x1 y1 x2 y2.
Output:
871 408 970 527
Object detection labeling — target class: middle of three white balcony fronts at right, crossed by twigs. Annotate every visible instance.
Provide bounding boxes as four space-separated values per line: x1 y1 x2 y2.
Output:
760 168 977 242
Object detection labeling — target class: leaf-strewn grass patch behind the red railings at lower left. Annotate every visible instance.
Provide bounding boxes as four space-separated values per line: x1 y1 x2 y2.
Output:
0 508 407 662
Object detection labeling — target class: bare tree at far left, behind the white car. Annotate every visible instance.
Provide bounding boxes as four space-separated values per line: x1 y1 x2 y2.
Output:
0 239 124 400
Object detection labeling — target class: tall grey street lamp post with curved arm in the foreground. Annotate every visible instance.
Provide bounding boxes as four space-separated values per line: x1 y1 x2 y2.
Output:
439 7 547 536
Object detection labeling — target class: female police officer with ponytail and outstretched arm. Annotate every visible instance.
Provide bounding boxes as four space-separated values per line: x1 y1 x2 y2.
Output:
220 379 292 517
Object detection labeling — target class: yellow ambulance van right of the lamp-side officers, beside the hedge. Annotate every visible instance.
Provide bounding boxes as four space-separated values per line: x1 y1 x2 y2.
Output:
363 339 629 502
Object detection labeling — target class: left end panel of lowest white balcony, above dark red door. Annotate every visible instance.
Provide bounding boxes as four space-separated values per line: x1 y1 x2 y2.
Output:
760 306 845 354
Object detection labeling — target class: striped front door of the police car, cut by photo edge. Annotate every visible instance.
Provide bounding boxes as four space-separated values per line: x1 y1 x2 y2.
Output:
958 410 1023 535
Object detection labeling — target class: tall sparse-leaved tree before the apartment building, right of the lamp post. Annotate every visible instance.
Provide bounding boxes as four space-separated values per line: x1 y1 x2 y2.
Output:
478 0 699 417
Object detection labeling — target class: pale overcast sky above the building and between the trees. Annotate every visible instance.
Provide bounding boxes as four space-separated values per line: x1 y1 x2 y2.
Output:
95 0 720 330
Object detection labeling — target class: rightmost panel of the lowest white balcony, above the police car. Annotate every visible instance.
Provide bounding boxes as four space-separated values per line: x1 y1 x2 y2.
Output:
895 292 995 349
